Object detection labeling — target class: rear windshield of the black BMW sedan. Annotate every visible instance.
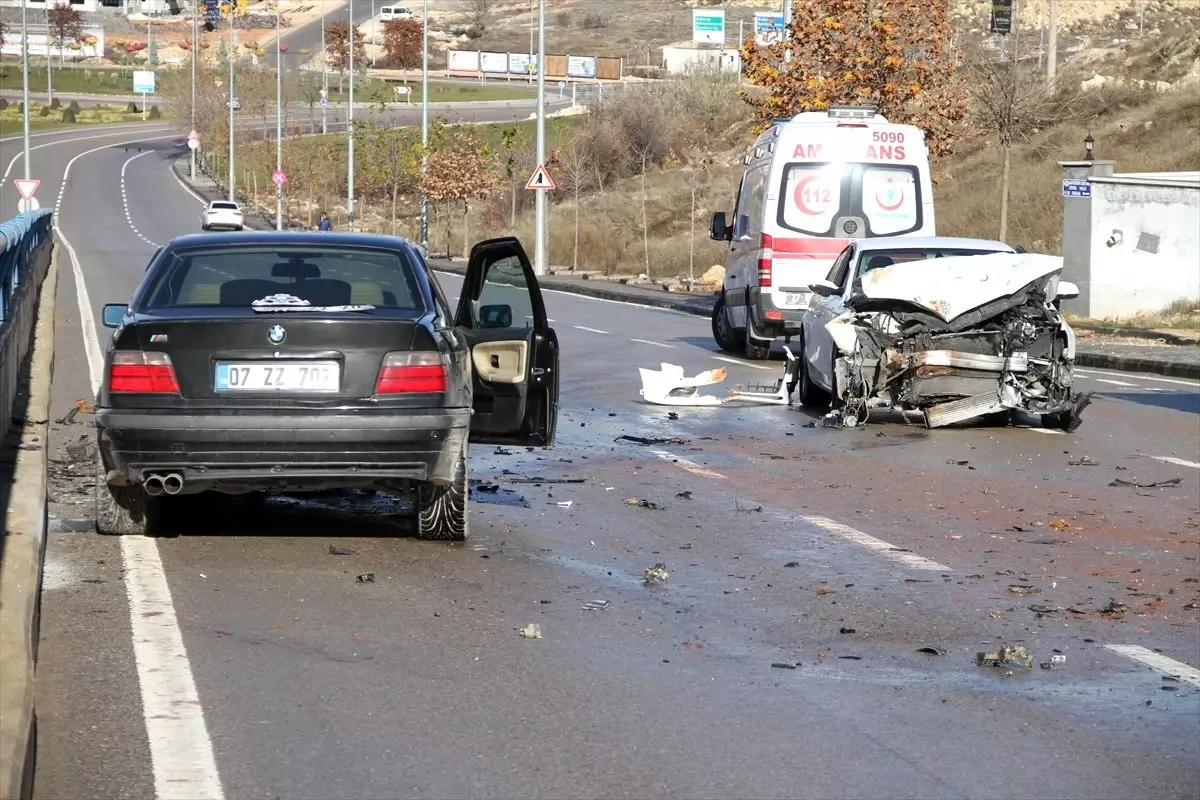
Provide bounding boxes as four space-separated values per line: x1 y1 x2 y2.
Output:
142 245 427 315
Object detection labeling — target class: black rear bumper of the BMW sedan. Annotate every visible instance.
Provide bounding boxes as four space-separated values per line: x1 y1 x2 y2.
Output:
96 409 470 492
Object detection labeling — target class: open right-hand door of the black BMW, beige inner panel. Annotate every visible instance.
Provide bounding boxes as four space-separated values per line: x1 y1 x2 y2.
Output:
455 236 558 447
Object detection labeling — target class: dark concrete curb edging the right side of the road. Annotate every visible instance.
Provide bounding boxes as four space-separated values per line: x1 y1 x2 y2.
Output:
430 259 1200 379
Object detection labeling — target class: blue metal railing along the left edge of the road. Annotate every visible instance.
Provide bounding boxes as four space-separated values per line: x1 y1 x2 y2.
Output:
0 209 54 441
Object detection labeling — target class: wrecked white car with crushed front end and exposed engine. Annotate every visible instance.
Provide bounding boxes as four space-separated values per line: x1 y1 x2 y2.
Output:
798 237 1088 431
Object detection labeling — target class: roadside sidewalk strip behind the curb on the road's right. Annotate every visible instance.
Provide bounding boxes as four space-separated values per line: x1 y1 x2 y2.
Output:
430 259 1200 379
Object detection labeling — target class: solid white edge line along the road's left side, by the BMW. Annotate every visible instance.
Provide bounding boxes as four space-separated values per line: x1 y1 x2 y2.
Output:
54 137 224 800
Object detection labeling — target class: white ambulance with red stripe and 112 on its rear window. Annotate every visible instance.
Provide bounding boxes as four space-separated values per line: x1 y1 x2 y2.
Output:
709 106 935 360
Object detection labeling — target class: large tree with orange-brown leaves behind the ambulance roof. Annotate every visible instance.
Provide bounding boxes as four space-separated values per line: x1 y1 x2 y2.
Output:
742 0 967 156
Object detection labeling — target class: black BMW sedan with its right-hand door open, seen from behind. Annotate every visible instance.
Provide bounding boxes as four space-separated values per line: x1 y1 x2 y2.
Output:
96 231 558 540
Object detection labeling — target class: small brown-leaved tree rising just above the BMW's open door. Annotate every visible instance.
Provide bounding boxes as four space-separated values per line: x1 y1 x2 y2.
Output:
421 122 492 258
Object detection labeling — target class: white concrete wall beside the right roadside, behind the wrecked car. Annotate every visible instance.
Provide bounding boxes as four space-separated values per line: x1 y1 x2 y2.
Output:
1076 173 1200 318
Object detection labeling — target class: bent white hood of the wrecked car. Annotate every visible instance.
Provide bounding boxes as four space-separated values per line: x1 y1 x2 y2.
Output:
846 253 1062 323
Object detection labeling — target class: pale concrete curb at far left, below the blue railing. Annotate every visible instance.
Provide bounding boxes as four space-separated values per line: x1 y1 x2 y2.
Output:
0 247 59 800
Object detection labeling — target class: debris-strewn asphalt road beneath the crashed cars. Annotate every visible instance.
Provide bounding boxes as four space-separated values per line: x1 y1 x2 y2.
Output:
11 126 1200 800
